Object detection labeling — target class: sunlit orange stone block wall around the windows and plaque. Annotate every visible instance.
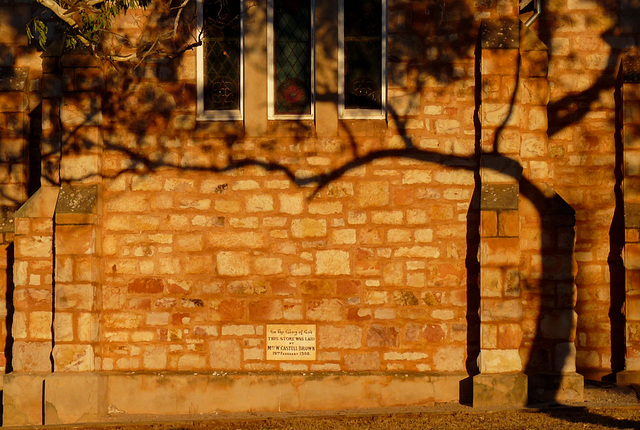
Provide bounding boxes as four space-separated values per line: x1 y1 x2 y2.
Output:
0 1 638 425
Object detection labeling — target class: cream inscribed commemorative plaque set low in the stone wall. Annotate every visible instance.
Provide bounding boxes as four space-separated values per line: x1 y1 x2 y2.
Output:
267 324 316 361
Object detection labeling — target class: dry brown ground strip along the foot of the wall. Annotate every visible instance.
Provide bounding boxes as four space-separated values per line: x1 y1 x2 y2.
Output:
16 383 640 430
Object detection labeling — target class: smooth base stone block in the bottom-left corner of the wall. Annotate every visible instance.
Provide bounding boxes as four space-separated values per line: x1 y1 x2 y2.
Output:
2 368 47 427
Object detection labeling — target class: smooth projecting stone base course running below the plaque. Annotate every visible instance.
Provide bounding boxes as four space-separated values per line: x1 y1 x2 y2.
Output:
4 372 467 426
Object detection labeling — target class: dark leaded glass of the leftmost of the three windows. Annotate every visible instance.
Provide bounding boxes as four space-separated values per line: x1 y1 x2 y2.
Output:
203 0 241 110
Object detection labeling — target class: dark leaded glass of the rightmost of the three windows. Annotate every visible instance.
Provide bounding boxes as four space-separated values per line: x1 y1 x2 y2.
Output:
344 0 382 110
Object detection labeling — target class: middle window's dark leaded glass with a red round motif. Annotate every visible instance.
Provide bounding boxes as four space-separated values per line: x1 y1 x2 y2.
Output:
273 0 311 114
